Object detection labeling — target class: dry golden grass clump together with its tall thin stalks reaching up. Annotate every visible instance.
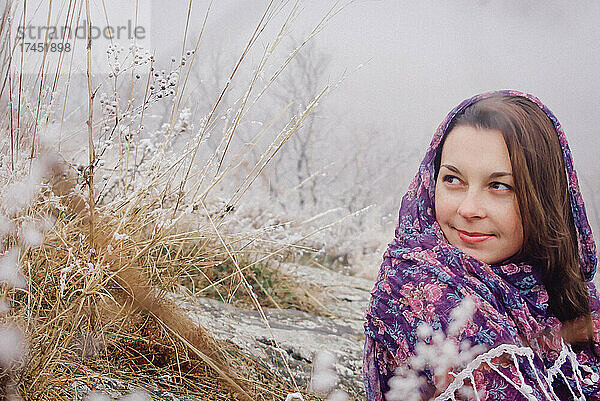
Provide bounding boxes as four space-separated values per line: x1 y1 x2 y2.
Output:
0 2 352 400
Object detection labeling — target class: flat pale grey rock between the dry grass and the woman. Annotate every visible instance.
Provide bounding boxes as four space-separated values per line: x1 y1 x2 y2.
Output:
174 264 373 399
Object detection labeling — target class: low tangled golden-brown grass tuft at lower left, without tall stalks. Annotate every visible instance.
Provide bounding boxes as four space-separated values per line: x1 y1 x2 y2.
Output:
4 170 328 400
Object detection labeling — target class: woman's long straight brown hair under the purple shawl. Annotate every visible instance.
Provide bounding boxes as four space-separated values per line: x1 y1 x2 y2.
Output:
435 95 591 332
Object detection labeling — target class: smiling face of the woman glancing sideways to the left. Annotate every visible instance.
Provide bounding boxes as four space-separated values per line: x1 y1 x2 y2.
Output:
435 126 523 264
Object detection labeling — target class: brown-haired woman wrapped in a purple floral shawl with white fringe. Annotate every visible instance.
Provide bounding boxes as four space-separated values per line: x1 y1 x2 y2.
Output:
363 91 600 401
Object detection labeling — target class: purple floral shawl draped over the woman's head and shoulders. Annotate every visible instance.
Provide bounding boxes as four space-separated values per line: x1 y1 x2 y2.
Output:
363 90 600 401
